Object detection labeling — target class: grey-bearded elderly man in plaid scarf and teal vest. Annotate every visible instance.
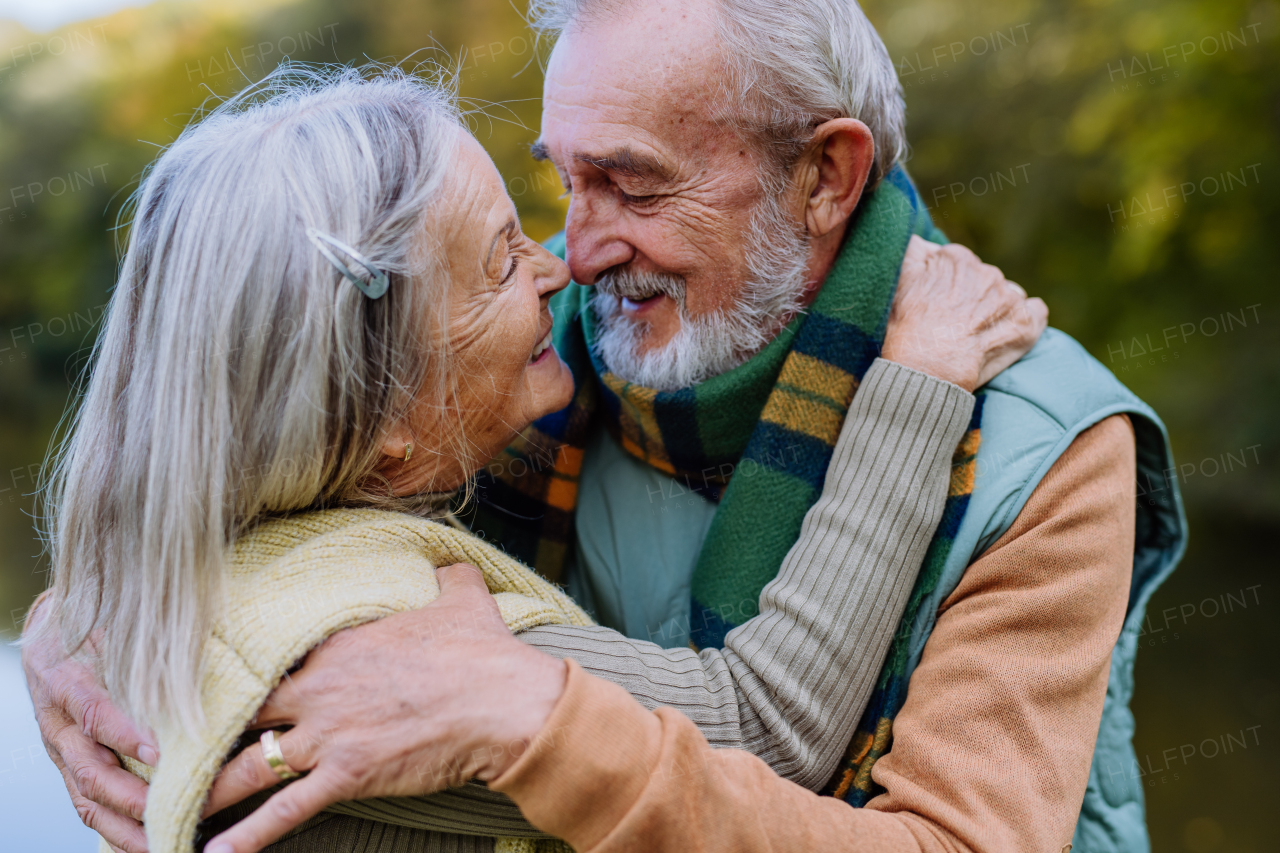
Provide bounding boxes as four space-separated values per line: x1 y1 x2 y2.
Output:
24 0 1183 853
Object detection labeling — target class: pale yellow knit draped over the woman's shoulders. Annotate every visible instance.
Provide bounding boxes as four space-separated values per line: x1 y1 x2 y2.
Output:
110 510 593 853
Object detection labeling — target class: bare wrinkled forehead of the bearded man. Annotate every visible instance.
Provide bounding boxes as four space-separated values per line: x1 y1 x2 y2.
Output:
543 0 723 158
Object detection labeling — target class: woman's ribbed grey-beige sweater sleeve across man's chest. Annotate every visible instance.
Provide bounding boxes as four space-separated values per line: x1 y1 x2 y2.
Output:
320 359 974 849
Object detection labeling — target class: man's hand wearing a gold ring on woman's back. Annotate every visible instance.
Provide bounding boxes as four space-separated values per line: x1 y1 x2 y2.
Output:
204 564 566 853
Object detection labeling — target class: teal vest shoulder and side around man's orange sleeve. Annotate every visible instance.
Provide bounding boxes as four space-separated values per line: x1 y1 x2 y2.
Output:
908 322 1187 853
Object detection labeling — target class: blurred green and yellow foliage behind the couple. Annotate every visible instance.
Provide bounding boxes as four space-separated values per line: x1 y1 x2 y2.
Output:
0 0 1280 853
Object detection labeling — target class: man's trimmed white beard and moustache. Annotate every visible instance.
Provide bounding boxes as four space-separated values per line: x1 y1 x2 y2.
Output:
591 193 809 391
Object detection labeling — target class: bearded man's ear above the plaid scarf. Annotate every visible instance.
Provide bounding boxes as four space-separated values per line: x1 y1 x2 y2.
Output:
797 118 876 240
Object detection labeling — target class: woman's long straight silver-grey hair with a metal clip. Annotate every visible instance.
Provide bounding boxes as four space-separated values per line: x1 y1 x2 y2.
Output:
33 65 462 726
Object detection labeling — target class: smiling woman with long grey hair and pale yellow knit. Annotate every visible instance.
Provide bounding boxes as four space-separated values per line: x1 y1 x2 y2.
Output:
28 69 1043 853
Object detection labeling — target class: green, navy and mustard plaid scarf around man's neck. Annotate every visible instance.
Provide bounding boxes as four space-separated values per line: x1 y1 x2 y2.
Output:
470 167 982 806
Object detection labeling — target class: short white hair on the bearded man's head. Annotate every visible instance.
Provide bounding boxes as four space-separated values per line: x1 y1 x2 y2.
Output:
530 0 906 180
